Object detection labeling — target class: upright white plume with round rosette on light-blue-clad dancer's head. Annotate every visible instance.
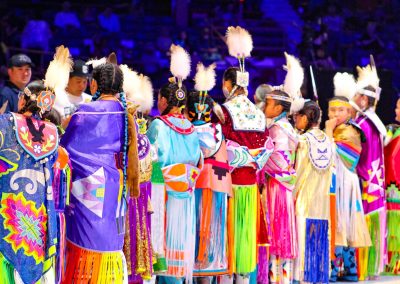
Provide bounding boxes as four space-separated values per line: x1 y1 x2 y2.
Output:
170 44 190 101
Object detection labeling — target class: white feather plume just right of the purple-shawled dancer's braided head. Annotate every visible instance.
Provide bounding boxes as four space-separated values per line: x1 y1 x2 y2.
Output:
119 64 154 112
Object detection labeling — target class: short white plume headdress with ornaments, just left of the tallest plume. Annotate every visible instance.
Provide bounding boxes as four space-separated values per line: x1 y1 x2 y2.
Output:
194 62 225 123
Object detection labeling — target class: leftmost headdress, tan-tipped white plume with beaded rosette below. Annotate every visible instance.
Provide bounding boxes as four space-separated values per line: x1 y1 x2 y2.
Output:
24 45 73 115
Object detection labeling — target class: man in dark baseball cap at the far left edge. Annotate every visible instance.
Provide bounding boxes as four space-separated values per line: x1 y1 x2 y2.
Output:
0 54 33 112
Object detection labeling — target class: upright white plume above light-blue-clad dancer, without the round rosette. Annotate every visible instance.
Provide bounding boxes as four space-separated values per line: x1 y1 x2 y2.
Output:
170 44 190 80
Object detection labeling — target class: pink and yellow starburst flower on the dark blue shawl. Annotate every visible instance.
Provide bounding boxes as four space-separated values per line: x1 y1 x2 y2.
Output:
0 192 47 264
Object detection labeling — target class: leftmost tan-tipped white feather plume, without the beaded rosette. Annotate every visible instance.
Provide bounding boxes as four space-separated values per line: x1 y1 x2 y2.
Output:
44 45 73 92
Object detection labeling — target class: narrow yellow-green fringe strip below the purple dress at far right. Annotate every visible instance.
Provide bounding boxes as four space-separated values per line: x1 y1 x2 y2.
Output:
367 212 381 276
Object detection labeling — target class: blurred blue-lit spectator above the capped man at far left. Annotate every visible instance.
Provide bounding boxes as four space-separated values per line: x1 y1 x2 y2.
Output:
21 11 52 51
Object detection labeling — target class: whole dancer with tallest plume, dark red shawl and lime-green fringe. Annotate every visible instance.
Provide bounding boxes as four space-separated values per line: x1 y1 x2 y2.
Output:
212 27 273 281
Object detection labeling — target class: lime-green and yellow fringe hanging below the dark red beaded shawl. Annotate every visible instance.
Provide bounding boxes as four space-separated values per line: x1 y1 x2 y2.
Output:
233 185 258 274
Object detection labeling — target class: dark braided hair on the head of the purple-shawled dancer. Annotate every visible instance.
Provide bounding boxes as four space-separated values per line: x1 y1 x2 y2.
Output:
92 62 124 95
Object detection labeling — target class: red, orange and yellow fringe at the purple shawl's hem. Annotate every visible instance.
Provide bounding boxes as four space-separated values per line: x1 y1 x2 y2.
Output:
63 242 124 284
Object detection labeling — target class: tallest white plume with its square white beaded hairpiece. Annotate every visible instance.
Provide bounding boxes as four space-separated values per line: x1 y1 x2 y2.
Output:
226 26 253 88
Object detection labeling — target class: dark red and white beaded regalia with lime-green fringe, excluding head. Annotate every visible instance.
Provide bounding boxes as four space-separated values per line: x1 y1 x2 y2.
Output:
216 95 273 275
